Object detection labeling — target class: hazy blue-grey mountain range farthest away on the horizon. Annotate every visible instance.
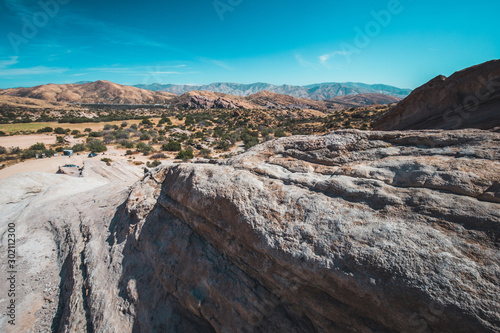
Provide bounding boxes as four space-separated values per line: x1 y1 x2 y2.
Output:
135 82 411 101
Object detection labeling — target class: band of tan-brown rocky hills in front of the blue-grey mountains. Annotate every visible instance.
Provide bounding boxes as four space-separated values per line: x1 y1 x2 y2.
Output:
0 81 400 112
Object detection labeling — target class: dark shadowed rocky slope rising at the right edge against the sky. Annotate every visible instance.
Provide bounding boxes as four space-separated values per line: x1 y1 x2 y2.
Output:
375 60 500 130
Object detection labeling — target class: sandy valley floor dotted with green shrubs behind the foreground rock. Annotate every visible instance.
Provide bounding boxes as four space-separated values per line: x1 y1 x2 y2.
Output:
0 98 389 167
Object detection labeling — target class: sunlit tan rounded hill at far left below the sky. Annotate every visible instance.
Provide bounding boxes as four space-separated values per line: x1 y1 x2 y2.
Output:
0 81 175 104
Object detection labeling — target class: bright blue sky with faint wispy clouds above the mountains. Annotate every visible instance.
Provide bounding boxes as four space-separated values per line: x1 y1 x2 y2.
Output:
0 0 500 88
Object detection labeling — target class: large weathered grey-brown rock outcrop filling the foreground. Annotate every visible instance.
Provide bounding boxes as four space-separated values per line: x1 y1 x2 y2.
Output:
0 130 500 332
